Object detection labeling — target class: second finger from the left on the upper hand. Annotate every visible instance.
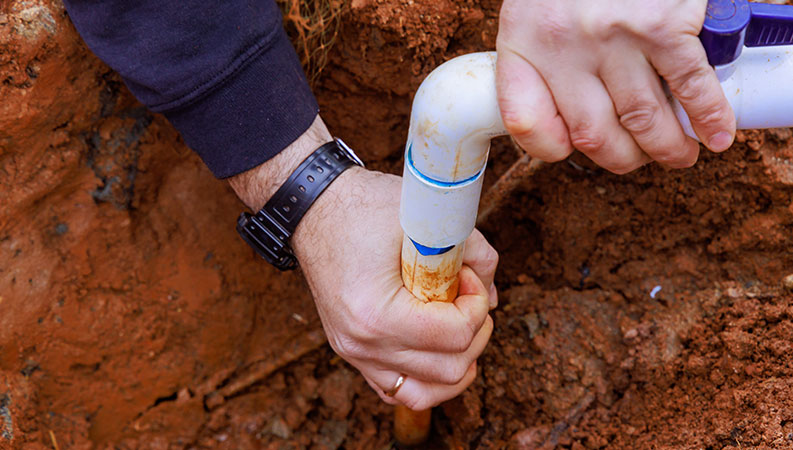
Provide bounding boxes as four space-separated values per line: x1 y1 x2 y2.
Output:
554 73 651 174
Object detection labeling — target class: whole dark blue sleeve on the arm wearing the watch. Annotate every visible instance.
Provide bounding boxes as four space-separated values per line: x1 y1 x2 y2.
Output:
64 0 319 178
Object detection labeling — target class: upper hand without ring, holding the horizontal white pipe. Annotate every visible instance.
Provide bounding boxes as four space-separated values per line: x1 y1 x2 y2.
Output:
496 0 735 173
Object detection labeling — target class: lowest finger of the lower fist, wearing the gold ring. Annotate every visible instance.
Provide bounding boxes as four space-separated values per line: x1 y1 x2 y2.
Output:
364 362 476 411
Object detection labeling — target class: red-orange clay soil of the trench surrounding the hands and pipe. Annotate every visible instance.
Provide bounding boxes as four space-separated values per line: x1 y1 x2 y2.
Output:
0 0 793 449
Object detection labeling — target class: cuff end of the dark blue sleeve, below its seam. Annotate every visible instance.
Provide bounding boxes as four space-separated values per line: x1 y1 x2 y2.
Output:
161 27 319 178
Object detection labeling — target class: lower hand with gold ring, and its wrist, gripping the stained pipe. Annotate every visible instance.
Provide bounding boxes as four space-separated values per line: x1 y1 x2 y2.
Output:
230 118 498 409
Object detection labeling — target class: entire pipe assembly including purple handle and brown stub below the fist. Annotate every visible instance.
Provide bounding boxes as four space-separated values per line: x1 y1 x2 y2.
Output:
394 0 793 445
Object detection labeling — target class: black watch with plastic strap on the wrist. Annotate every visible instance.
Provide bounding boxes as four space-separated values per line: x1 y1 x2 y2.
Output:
237 139 363 270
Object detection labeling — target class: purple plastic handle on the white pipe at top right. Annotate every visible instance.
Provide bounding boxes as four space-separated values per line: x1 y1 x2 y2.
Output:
699 0 793 66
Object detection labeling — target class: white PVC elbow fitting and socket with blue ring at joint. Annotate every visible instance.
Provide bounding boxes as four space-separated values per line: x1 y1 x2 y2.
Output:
400 52 507 253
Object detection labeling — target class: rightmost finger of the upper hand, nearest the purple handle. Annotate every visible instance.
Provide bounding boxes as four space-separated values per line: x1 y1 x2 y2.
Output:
650 35 735 152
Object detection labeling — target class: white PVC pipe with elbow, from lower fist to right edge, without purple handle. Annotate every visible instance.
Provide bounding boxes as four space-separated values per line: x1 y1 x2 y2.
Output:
399 46 793 301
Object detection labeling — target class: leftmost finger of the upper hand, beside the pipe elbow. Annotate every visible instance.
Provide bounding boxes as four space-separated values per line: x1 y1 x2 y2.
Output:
498 49 573 163
